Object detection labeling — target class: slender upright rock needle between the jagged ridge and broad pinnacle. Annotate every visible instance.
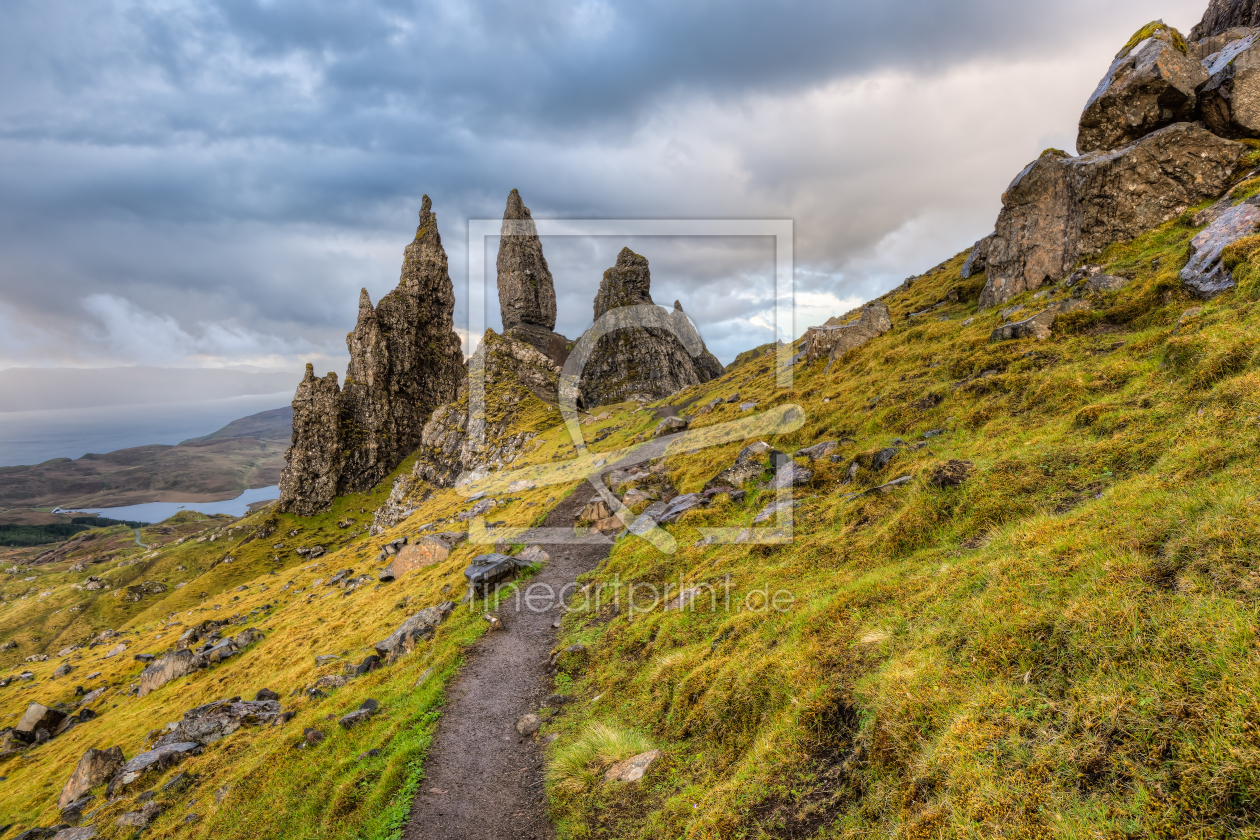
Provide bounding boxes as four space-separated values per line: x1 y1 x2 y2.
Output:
496 190 568 364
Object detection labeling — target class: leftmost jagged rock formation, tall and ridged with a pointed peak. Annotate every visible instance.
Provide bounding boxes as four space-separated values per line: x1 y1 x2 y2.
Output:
280 195 464 516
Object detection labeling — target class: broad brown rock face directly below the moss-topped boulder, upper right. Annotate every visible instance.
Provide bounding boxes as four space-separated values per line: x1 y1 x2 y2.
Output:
980 122 1246 307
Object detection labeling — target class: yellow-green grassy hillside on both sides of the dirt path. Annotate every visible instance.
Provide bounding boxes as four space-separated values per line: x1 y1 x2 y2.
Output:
0 197 1260 839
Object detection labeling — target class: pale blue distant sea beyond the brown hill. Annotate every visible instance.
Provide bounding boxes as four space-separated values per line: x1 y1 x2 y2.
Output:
0 389 294 467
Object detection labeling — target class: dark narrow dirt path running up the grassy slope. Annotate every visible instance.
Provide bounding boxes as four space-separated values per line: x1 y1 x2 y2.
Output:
403 484 611 840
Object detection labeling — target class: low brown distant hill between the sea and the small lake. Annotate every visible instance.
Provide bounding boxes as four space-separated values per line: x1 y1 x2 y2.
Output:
0 407 294 513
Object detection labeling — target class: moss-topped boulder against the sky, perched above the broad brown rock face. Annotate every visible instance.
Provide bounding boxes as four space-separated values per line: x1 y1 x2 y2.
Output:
1076 28 1207 155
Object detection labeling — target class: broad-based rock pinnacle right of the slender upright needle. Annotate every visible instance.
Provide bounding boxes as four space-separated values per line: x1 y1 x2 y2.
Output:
566 248 725 407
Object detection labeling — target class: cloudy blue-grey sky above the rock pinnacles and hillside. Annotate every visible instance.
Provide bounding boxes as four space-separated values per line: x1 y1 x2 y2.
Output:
0 0 1206 418
